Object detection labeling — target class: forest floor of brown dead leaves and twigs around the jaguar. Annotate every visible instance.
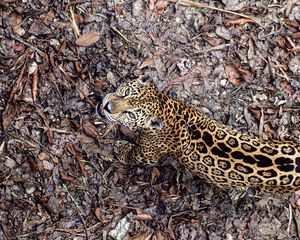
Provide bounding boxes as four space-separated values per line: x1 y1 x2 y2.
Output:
0 0 300 240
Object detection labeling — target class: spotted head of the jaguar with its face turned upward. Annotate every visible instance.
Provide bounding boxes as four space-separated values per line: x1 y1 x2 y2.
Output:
102 78 164 131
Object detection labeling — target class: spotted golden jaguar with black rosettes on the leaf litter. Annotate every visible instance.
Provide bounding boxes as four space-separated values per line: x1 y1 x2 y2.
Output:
102 77 300 193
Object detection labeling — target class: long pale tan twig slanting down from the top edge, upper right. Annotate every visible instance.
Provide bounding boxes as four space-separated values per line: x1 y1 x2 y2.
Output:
169 0 261 26
